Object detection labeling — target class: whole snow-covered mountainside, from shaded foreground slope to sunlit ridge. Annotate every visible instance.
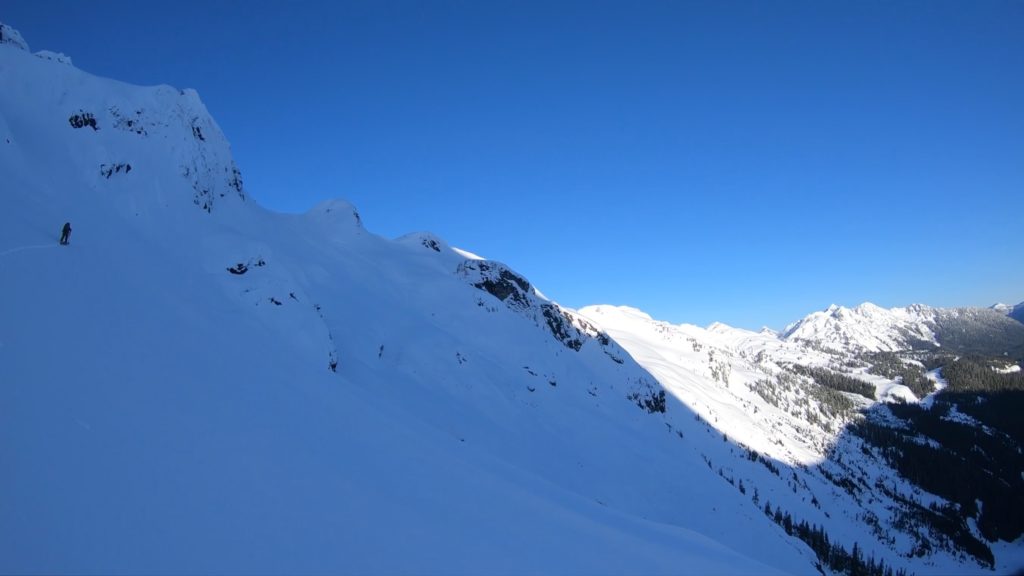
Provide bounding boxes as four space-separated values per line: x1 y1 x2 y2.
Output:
0 25 1024 574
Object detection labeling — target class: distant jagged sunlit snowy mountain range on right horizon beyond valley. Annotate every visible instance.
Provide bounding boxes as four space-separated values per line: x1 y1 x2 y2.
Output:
781 302 1024 356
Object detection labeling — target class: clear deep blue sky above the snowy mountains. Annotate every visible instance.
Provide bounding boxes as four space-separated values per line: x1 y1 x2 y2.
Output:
0 0 1024 329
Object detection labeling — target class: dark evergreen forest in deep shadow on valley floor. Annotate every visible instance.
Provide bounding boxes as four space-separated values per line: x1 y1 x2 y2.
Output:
851 357 1024 553
